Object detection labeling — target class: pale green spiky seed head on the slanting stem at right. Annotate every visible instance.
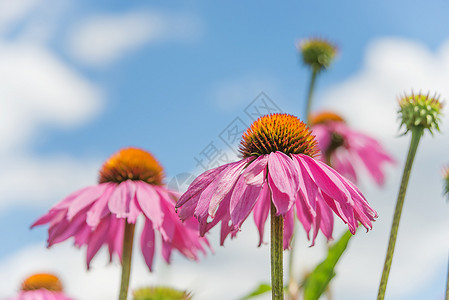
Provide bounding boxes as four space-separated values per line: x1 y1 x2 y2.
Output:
399 92 443 134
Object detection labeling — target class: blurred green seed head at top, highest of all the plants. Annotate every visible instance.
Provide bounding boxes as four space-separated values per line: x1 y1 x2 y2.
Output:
298 38 337 72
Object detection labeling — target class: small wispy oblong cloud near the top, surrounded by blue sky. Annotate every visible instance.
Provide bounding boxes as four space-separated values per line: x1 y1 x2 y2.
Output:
68 11 201 66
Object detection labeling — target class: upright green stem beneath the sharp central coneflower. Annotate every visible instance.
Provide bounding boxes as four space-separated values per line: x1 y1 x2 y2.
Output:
271 202 284 300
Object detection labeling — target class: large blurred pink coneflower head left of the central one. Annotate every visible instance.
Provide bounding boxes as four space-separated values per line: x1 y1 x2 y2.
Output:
32 148 208 271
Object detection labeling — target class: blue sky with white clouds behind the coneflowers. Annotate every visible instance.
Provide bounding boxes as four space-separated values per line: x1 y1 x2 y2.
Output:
0 0 449 299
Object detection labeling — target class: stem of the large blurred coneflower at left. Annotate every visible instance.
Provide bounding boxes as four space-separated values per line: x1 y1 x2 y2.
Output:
119 222 135 300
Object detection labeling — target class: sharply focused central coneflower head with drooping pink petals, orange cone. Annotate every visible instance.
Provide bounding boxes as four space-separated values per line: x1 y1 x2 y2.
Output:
176 114 377 249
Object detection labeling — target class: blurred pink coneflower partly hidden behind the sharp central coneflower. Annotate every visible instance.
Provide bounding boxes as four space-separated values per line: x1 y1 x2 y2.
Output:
310 111 395 185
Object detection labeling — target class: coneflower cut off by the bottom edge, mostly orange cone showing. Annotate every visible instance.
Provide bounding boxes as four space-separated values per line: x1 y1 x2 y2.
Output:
8 273 72 300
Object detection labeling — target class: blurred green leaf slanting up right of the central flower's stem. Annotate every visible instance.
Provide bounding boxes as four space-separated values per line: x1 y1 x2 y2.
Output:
303 231 352 300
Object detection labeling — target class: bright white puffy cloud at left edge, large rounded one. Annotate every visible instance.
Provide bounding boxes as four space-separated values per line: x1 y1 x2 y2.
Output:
0 43 102 151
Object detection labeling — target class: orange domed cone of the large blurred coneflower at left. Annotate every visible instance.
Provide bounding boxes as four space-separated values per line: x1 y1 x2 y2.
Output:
98 148 164 185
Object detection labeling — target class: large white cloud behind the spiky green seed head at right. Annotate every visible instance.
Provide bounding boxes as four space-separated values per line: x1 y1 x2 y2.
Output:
318 38 449 299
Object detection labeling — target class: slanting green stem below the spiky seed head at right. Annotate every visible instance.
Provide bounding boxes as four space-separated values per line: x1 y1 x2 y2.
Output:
377 127 424 300
